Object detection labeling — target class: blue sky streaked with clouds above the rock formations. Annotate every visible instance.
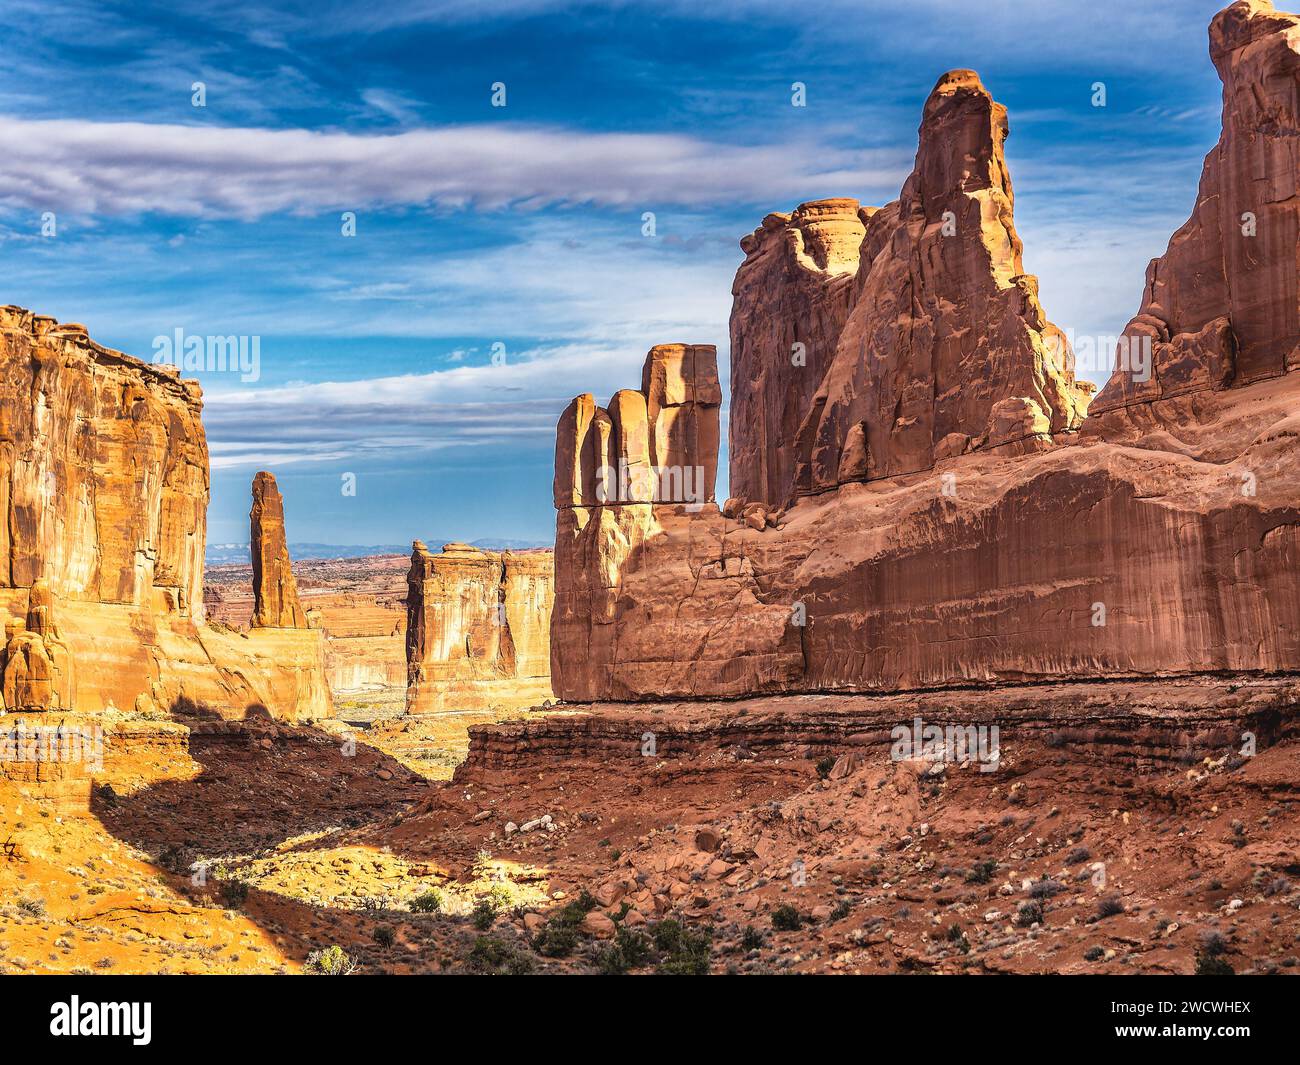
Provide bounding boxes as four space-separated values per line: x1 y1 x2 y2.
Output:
0 0 1219 544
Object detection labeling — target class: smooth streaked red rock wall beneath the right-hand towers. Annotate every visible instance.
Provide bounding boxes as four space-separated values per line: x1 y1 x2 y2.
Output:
569 380 1300 701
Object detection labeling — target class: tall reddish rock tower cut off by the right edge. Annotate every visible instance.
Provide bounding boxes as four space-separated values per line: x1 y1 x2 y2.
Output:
1093 0 1300 424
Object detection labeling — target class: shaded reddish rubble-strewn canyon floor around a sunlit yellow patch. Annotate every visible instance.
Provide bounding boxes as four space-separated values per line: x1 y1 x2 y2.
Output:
76 691 1300 973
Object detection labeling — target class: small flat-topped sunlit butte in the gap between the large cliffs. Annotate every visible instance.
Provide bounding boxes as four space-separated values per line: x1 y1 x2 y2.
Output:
407 540 554 714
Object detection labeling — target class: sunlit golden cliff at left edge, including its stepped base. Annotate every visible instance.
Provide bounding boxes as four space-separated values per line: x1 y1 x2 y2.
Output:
0 307 332 718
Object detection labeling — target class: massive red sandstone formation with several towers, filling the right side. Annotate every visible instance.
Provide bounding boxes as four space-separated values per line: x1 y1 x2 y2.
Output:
551 0 1300 702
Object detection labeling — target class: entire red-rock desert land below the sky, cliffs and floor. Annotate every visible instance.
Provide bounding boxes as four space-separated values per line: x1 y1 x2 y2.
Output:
0 0 1300 998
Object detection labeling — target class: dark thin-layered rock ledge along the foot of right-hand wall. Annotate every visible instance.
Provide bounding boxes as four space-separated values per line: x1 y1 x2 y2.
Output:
455 677 1300 782
